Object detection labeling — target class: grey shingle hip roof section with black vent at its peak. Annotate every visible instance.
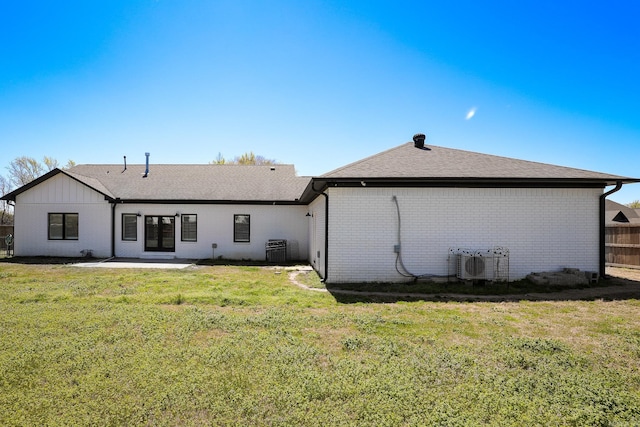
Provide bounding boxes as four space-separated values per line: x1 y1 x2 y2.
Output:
301 142 640 201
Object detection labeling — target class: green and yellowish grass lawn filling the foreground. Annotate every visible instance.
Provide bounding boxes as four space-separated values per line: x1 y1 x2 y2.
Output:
0 262 640 426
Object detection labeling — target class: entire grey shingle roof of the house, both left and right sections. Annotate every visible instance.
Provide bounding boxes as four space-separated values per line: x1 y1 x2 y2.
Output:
3 142 640 203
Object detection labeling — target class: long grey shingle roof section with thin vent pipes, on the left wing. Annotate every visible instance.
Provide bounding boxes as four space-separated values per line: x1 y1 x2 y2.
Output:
4 164 310 203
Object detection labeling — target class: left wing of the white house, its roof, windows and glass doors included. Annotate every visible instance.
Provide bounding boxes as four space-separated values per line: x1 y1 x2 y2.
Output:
0 164 309 260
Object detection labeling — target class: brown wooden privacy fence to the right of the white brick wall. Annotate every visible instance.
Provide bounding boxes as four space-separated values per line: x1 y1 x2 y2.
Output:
605 225 640 268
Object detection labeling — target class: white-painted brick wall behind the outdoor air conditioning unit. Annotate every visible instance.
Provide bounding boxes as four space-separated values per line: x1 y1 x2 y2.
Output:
326 187 602 283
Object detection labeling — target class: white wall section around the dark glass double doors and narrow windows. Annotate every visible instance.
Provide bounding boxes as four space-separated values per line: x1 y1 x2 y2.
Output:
115 204 309 260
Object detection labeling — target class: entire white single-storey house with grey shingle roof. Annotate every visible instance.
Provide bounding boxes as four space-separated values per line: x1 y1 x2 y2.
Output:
3 134 639 283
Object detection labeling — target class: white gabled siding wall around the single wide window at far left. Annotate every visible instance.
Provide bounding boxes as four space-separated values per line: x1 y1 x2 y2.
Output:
14 174 111 257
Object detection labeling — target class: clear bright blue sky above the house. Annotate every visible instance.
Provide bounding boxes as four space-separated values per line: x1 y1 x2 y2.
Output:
0 0 640 203
